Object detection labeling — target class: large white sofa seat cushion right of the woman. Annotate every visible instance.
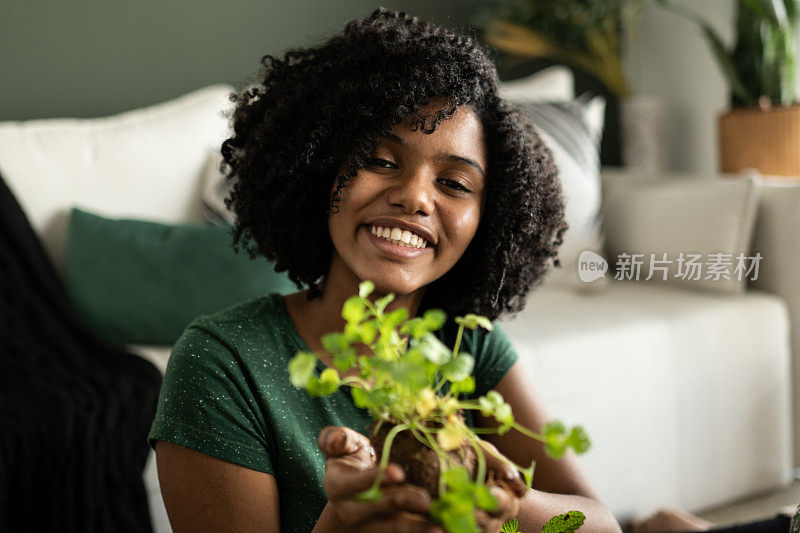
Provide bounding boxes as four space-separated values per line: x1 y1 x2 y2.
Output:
501 279 791 519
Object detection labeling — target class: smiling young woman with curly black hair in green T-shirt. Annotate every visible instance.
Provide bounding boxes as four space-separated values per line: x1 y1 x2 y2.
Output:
150 10 619 533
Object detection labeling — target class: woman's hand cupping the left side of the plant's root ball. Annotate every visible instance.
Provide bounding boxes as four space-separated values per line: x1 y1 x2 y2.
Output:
317 426 444 533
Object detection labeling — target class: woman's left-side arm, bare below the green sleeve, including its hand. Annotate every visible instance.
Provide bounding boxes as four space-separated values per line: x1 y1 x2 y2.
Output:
156 434 440 533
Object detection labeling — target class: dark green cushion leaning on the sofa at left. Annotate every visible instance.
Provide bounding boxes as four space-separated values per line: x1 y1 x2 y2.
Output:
64 209 297 345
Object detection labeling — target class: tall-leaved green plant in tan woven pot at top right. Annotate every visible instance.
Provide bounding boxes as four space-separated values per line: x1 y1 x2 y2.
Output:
657 0 800 176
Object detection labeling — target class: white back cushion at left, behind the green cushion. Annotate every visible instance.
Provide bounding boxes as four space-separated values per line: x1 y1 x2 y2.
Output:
0 85 233 272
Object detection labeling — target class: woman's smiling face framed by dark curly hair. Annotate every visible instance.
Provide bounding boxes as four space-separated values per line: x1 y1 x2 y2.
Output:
329 102 487 296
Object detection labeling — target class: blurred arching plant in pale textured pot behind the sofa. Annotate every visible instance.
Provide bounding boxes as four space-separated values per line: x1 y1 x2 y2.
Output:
475 0 667 173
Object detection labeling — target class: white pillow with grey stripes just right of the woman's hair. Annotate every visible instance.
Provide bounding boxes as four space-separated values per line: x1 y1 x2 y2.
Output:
521 96 608 292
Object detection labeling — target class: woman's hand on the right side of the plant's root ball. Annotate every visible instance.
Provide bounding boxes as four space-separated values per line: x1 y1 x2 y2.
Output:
475 440 528 533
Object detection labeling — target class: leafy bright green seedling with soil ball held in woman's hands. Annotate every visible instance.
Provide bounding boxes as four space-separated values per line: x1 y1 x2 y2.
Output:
288 281 589 533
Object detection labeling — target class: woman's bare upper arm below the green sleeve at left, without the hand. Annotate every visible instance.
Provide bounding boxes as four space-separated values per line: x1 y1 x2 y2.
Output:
156 441 280 533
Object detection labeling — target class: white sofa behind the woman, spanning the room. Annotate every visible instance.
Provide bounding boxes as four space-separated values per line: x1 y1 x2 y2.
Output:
0 86 800 531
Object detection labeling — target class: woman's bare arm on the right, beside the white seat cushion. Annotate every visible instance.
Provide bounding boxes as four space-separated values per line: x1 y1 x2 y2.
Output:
476 362 621 533
